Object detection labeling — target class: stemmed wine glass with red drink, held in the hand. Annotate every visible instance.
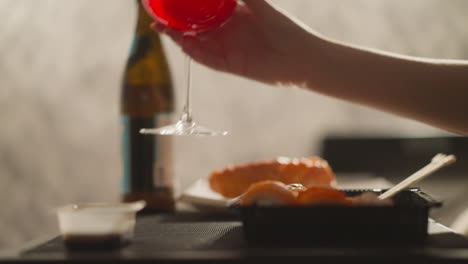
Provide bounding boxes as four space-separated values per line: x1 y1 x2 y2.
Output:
140 0 237 136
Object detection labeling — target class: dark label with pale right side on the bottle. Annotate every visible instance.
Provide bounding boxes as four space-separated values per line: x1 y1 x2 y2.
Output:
121 113 173 193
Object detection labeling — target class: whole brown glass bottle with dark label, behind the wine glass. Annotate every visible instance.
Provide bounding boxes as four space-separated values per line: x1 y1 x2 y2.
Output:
121 1 175 212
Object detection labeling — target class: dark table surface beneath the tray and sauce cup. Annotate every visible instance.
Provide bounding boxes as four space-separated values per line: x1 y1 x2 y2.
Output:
0 213 468 264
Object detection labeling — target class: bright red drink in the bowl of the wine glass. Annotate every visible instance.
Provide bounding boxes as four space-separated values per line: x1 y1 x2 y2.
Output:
142 0 237 33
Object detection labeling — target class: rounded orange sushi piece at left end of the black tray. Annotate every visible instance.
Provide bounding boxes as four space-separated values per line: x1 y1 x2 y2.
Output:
240 181 296 206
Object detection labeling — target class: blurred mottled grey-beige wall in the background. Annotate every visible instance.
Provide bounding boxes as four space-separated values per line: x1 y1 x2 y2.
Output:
0 0 468 248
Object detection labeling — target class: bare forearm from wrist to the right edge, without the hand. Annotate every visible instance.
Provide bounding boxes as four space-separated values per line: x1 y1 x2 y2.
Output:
306 34 468 135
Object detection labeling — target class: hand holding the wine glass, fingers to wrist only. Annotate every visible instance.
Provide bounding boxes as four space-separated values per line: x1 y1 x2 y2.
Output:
152 0 320 85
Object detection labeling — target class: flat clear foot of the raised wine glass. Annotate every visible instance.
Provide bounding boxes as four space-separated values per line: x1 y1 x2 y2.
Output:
140 120 228 136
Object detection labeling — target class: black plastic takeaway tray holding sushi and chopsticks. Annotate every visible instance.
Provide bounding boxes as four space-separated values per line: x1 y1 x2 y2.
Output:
239 188 442 244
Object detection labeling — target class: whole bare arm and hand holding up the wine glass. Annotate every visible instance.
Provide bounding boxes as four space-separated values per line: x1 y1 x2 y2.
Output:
153 0 468 135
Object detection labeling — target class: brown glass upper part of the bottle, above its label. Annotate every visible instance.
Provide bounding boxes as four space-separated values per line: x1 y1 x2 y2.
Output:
122 3 174 118
